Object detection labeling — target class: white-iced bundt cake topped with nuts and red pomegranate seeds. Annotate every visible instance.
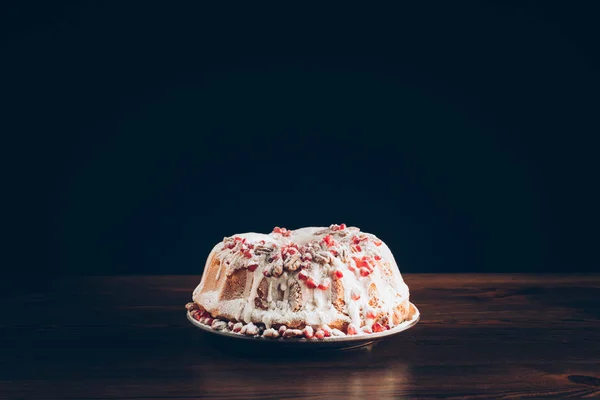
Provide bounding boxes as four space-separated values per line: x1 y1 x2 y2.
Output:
186 224 414 339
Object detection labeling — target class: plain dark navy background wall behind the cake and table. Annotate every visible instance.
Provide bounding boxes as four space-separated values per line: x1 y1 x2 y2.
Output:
0 1 600 283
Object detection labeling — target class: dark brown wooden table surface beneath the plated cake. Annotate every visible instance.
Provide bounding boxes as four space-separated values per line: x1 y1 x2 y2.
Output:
0 274 600 400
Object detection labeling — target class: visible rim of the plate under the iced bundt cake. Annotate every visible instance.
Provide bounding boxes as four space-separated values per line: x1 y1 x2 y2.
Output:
186 302 421 345
